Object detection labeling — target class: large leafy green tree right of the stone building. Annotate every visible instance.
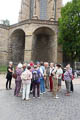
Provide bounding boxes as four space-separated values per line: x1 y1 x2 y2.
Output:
58 0 80 62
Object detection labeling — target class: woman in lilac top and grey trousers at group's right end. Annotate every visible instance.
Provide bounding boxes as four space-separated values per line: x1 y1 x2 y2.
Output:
64 65 72 96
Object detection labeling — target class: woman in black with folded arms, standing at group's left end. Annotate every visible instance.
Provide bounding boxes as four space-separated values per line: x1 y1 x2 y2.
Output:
6 62 13 90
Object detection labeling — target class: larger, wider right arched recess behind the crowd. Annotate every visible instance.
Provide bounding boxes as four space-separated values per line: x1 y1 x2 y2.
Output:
32 27 55 62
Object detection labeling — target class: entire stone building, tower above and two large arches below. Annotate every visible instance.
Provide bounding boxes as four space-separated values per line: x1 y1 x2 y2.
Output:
0 0 62 65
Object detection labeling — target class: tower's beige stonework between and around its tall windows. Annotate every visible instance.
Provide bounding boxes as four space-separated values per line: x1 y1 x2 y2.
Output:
19 0 62 21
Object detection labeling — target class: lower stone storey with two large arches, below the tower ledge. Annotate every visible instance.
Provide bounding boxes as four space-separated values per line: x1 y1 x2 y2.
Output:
0 20 62 65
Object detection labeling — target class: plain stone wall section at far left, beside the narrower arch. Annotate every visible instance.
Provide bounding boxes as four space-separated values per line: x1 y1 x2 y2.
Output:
0 25 8 65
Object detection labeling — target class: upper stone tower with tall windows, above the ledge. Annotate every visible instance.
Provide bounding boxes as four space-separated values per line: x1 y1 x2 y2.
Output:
19 0 62 21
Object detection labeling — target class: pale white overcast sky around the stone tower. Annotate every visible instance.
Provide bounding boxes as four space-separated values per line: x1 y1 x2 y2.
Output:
0 0 71 24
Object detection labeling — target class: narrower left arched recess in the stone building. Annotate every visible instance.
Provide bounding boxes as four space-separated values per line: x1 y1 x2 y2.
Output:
11 29 25 64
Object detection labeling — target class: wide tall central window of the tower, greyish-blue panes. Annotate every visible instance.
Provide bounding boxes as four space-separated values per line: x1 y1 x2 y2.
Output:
40 0 47 20
